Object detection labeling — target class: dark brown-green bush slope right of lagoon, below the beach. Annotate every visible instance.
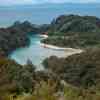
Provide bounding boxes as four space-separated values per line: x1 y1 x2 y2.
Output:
44 49 100 88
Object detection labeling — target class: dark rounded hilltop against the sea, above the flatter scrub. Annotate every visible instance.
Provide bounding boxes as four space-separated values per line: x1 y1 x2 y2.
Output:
50 15 100 32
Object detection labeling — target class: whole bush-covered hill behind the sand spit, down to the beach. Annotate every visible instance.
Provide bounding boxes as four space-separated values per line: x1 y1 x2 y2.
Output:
42 15 100 48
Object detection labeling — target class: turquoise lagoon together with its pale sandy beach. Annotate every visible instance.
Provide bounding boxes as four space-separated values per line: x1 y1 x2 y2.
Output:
10 35 82 70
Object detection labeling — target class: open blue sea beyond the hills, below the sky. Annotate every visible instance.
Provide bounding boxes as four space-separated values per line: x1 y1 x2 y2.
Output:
0 4 100 27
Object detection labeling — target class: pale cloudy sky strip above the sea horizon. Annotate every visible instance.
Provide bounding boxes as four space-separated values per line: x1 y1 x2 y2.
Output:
0 0 100 5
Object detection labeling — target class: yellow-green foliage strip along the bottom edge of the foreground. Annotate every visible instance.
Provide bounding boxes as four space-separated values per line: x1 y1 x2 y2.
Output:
7 80 100 100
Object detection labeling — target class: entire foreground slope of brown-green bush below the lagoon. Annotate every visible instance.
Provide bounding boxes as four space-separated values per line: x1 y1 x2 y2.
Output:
0 49 100 100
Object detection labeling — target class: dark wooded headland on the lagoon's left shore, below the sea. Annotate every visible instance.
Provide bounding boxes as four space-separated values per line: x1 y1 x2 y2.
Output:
0 21 42 56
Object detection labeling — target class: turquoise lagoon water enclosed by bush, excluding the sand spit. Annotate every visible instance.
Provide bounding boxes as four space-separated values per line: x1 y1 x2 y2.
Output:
10 35 70 69
